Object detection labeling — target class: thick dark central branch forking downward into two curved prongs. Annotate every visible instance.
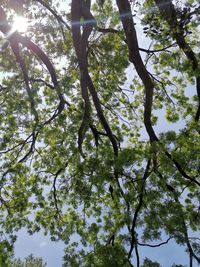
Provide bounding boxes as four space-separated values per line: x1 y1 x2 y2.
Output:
71 0 118 155
